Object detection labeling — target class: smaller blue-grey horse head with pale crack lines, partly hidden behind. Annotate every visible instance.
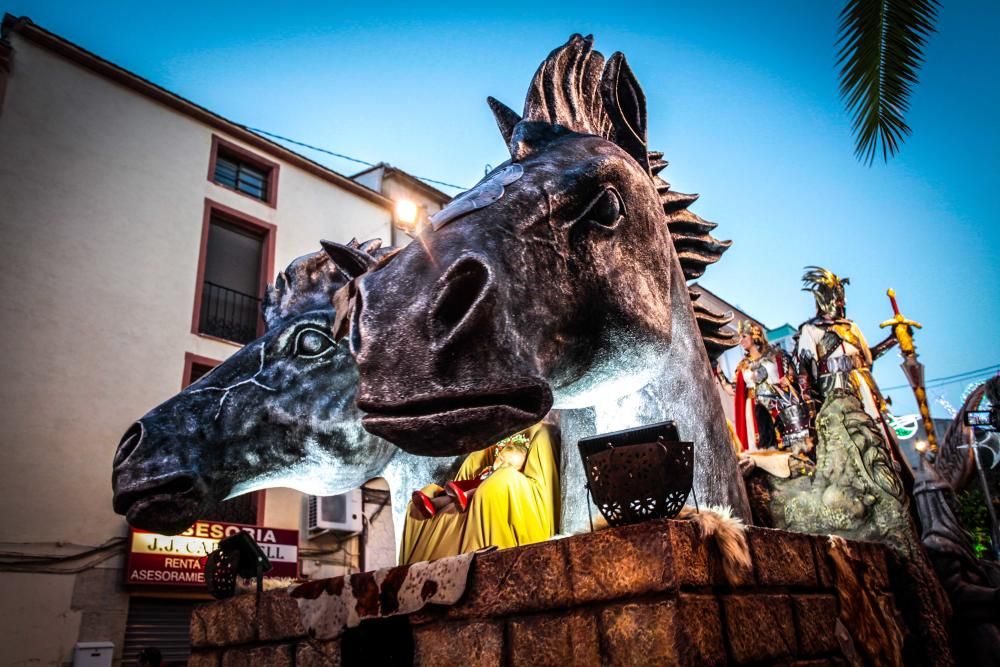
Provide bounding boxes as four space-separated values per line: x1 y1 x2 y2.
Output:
112 242 459 535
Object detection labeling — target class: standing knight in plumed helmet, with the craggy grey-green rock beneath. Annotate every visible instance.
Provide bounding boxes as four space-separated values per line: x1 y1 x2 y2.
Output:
751 267 919 556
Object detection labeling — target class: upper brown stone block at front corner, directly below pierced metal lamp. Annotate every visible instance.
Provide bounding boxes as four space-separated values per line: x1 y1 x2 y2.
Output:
563 521 676 604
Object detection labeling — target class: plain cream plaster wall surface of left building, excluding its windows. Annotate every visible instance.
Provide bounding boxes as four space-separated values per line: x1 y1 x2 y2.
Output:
0 33 392 665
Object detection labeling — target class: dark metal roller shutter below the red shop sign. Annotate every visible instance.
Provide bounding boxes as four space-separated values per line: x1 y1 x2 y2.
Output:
122 597 201 665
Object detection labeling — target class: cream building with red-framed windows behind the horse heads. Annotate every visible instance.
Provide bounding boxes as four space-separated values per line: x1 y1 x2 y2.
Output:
0 15 438 665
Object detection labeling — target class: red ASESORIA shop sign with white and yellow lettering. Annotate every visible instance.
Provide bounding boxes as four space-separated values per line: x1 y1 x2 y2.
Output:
125 521 299 587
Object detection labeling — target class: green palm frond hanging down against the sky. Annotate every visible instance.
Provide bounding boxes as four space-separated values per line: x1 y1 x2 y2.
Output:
837 0 938 165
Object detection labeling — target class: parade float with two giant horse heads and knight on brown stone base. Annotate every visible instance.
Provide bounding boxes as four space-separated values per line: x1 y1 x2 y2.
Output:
113 35 995 665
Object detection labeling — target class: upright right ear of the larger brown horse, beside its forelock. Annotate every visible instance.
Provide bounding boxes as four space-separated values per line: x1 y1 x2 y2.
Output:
601 52 649 171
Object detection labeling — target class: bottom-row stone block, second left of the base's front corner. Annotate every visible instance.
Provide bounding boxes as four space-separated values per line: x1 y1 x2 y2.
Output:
507 611 601 667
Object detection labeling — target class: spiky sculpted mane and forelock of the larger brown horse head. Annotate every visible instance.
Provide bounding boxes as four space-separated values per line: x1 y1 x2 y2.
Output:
512 34 739 360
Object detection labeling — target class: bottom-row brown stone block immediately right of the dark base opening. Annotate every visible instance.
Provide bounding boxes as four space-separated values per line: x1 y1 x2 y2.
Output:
413 621 504 667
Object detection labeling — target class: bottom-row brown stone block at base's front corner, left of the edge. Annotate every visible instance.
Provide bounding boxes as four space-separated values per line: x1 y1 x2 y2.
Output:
601 600 679 665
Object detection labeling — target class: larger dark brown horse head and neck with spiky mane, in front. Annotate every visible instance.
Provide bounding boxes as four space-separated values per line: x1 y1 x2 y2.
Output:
351 35 750 532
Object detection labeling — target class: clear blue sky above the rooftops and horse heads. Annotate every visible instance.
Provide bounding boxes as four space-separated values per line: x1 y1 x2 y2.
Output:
7 0 1000 416
